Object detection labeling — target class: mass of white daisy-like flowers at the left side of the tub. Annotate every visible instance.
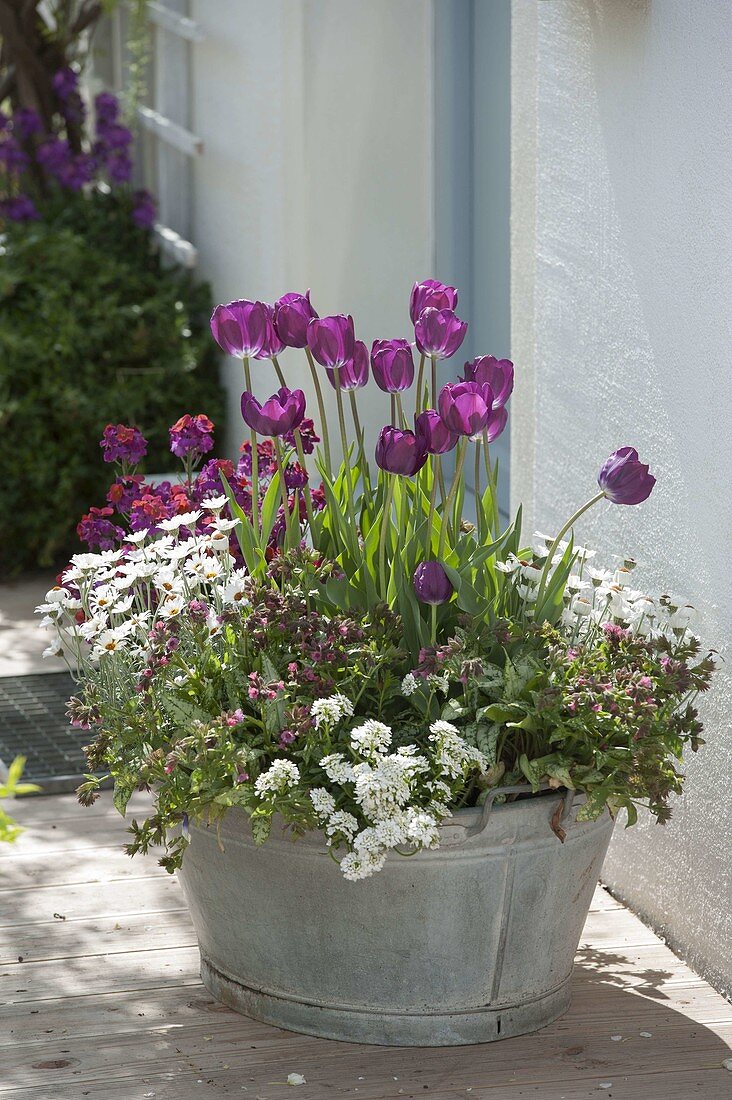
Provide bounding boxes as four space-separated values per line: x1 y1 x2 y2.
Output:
36 519 245 667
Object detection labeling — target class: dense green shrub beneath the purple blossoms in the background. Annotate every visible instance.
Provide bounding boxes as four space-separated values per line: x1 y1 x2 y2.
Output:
0 193 223 575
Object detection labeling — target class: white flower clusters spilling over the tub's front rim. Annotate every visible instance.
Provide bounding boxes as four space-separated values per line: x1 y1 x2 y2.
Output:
310 721 488 881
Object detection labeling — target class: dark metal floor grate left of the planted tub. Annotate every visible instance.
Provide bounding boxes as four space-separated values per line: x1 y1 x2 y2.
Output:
0 672 90 794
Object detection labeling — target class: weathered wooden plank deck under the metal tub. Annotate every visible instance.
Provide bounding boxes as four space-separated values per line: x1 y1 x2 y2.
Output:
0 795 732 1100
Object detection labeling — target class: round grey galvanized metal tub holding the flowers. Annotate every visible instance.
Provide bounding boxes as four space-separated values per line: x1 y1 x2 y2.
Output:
179 793 613 1046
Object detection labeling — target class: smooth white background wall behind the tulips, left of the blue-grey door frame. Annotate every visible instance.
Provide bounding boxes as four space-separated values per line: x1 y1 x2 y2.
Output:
190 0 435 450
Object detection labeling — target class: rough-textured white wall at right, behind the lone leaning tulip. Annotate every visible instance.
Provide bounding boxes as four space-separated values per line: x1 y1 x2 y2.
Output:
512 0 732 990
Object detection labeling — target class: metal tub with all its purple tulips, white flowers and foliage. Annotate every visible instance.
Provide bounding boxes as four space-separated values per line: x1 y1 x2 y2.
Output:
40 279 713 1045
